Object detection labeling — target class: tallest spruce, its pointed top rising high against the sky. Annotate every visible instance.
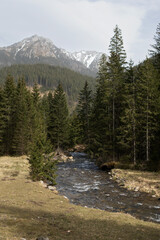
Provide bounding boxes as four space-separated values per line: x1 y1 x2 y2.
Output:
108 25 126 161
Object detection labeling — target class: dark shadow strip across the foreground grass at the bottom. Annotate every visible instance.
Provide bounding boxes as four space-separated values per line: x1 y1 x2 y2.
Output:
0 205 160 240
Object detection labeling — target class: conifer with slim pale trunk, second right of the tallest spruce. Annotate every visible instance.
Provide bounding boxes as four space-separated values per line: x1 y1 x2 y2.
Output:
137 59 159 162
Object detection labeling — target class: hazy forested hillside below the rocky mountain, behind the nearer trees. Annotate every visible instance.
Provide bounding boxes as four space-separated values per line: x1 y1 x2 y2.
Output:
0 64 96 106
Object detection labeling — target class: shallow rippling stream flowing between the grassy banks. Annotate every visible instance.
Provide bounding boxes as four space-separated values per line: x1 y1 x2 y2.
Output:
56 152 160 223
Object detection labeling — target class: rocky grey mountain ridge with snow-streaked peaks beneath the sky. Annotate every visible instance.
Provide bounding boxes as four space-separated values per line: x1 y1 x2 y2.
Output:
0 35 102 76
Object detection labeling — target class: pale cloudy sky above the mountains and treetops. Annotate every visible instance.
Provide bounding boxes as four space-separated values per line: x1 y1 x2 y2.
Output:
0 0 160 63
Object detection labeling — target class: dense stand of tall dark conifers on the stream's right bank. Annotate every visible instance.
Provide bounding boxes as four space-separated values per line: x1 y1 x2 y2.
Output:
73 24 160 170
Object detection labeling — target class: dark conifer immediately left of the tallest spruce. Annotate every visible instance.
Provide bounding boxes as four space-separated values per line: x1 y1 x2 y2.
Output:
91 55 112 159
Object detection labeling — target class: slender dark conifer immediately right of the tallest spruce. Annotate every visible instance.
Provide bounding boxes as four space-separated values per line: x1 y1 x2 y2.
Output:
118 61 137 165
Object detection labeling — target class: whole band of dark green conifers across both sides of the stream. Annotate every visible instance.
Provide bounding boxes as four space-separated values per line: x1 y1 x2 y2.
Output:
0 24 160 183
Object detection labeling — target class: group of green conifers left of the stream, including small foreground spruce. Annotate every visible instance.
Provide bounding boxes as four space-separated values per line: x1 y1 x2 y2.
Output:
0 76 69 183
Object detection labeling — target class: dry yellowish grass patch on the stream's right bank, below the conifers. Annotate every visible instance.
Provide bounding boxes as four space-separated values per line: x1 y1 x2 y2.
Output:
112 169 160 197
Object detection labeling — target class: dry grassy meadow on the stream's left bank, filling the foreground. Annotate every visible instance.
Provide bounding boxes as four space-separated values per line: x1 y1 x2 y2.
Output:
0 156 160 240
